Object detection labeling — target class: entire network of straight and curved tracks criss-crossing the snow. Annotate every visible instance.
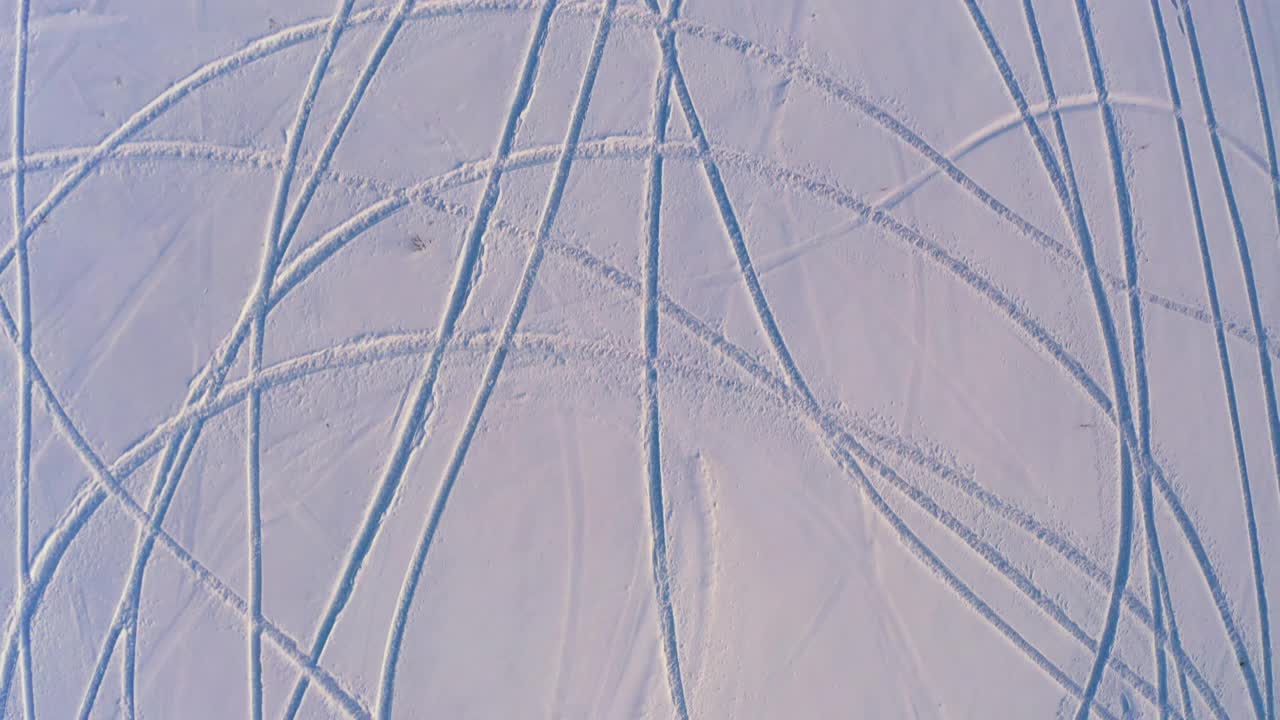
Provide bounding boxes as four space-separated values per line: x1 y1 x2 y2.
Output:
0 0 1280 720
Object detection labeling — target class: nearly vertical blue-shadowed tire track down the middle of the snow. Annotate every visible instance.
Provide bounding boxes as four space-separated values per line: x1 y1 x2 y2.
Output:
641 0 689 720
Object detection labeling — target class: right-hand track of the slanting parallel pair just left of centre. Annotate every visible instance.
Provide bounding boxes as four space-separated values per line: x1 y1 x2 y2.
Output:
378 0 617 720
